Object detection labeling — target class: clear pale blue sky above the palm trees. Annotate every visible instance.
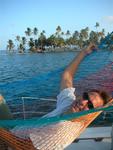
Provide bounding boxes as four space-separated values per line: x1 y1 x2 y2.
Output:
0 0 113 50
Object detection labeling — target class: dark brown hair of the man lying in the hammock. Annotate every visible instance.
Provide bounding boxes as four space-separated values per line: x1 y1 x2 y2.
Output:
88 89 112 104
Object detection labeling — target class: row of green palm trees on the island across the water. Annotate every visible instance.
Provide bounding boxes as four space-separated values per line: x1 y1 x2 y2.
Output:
7 22 113 53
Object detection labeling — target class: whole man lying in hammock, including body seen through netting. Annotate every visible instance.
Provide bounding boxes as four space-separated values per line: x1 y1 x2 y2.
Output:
28 44 111 150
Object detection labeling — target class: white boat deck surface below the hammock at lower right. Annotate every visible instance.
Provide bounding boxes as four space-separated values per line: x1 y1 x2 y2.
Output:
65 127 112 150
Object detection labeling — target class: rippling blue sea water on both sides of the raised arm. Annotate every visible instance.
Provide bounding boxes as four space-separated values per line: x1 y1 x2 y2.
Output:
0 50 113 122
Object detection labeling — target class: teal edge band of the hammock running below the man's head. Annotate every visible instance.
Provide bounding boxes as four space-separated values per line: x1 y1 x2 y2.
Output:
0 106 113 129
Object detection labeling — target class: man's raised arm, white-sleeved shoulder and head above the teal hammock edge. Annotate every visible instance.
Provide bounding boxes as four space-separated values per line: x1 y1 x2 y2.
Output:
44 43 111 117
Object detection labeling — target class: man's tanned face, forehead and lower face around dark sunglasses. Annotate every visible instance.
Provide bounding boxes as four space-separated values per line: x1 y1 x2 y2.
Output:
72 92 104 112
